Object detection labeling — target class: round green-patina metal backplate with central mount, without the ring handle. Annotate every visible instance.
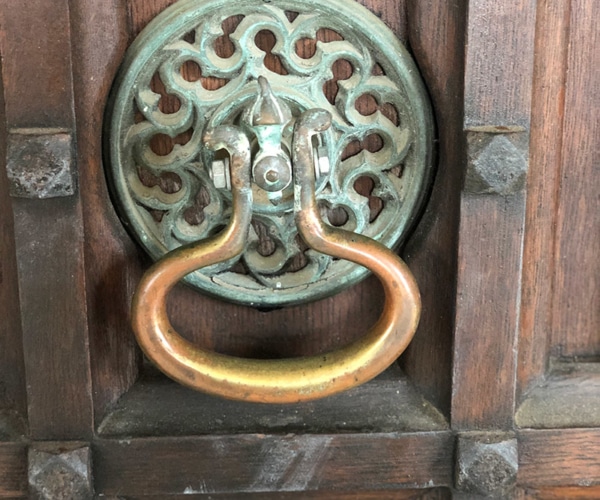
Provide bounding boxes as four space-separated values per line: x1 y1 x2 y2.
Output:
105 0 433 307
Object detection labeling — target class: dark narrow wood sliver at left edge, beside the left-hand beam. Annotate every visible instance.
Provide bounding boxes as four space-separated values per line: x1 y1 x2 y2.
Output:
0 54 27 415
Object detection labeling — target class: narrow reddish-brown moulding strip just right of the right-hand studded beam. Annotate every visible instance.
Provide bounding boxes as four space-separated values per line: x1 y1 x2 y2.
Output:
518 0 570 395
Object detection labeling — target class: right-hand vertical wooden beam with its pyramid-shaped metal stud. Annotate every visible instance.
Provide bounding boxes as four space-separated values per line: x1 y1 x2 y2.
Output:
452 0 536 430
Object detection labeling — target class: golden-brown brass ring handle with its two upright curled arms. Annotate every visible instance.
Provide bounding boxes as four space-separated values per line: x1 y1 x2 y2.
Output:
132 110 421 403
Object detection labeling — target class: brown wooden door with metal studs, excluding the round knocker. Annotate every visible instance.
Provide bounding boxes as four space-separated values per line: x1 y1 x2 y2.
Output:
0 0 600 499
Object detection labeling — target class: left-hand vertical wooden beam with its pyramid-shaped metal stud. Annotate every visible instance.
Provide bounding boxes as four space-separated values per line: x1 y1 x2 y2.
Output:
0 0 92 440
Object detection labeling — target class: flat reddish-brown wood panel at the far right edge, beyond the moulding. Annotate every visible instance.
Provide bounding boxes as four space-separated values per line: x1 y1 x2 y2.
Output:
552 0 600 357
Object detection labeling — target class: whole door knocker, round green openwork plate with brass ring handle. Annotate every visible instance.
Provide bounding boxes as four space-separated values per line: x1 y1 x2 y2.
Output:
105 0 433 403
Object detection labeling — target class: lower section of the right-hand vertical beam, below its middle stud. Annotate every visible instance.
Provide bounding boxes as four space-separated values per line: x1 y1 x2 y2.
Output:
452 195 523 430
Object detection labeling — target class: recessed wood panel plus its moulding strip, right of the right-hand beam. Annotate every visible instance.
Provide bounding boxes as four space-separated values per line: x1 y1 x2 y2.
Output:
519 0 600 393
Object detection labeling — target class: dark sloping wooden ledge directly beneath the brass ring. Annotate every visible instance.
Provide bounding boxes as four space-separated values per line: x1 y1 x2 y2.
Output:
98 368 448 438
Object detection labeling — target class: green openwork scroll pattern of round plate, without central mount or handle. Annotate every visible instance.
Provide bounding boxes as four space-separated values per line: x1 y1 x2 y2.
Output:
113 0 428 303
